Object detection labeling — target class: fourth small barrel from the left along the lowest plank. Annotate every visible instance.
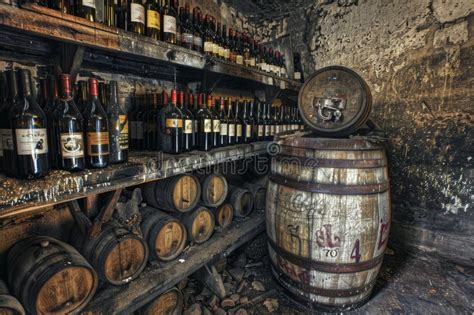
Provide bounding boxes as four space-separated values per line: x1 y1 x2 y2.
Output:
181 206 215 244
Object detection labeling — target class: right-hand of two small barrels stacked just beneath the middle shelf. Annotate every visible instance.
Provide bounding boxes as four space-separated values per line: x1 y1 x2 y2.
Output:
200 174 228 207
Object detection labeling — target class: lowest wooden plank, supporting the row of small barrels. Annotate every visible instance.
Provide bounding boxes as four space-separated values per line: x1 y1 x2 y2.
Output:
85 211 265 314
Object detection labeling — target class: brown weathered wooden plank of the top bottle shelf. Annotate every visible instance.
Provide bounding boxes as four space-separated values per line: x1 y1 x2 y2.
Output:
0 3 301 90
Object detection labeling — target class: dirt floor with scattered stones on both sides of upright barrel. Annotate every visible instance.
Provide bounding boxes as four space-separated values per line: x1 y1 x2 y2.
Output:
184 233 474 315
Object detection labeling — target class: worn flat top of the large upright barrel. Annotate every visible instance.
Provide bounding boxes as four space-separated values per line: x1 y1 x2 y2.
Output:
280 137 382 151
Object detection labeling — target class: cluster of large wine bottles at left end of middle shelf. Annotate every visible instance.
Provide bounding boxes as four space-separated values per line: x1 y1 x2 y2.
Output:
0 69 128 179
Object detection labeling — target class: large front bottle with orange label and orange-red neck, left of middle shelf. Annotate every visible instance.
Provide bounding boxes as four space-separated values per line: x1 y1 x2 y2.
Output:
85 78 110 168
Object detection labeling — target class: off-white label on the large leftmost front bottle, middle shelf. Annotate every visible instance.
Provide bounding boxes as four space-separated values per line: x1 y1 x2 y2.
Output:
15 128 48 155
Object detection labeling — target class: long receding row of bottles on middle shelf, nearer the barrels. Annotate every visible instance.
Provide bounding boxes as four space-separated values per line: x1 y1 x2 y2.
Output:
126 90 303 154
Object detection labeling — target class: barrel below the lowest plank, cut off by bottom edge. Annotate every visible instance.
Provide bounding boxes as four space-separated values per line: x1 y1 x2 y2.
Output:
139 288 183 315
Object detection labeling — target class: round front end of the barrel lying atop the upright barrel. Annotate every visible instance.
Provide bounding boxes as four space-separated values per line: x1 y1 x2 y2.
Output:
298 66 372 136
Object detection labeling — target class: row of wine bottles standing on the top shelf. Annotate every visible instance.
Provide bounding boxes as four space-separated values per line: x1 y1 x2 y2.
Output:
25 0 300 80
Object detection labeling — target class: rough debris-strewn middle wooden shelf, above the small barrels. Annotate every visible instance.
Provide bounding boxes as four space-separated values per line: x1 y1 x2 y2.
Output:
0 142 267 219
